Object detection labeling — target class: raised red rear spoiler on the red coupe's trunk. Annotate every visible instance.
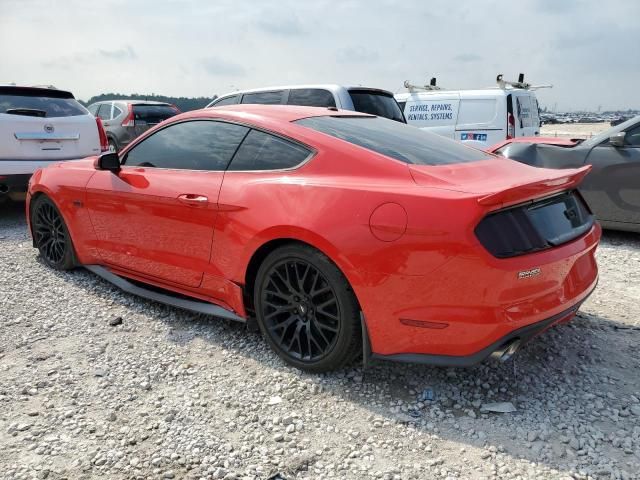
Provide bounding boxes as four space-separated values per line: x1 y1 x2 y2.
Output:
478 165 591 207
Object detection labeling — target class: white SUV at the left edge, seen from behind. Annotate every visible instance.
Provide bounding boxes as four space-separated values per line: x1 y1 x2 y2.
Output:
0 85 108 201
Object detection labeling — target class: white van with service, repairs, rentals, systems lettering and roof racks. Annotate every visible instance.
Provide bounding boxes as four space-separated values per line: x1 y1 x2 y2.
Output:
395 76 540 149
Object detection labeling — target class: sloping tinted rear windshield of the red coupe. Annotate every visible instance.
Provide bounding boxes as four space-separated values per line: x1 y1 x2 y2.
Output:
295 116 491 165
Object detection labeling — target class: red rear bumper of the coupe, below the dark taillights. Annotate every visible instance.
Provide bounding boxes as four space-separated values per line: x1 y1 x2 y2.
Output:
356 224 601 365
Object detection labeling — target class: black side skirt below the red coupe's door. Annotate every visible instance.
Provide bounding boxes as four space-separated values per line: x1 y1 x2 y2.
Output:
84 265 246 323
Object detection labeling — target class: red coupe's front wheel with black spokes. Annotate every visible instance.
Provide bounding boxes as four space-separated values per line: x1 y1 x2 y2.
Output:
30 195 76 270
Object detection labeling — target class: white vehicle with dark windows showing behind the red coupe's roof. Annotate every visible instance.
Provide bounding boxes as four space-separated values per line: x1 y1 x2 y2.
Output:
207 85 406 123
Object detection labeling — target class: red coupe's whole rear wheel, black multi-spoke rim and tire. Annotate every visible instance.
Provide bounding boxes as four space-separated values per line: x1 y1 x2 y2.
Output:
254 244 362 373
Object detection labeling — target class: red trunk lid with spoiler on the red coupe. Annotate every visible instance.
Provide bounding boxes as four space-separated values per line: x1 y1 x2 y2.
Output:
409 157 591 206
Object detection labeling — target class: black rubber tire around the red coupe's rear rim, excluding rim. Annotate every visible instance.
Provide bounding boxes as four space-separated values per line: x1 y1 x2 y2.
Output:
254 245 361 373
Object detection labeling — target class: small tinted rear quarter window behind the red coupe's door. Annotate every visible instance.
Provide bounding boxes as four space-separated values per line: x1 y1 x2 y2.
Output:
229 130 311 171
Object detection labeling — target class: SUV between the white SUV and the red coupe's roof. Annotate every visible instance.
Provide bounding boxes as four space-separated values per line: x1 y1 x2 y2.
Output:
88 100 180 152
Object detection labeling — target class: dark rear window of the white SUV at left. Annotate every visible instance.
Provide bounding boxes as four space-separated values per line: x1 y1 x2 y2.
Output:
0 88 87 118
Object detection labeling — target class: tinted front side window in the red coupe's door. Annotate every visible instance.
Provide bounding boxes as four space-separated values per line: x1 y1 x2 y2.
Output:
123 120 249 171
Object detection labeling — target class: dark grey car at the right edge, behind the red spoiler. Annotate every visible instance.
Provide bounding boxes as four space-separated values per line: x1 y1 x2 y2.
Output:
488 116 640 232
